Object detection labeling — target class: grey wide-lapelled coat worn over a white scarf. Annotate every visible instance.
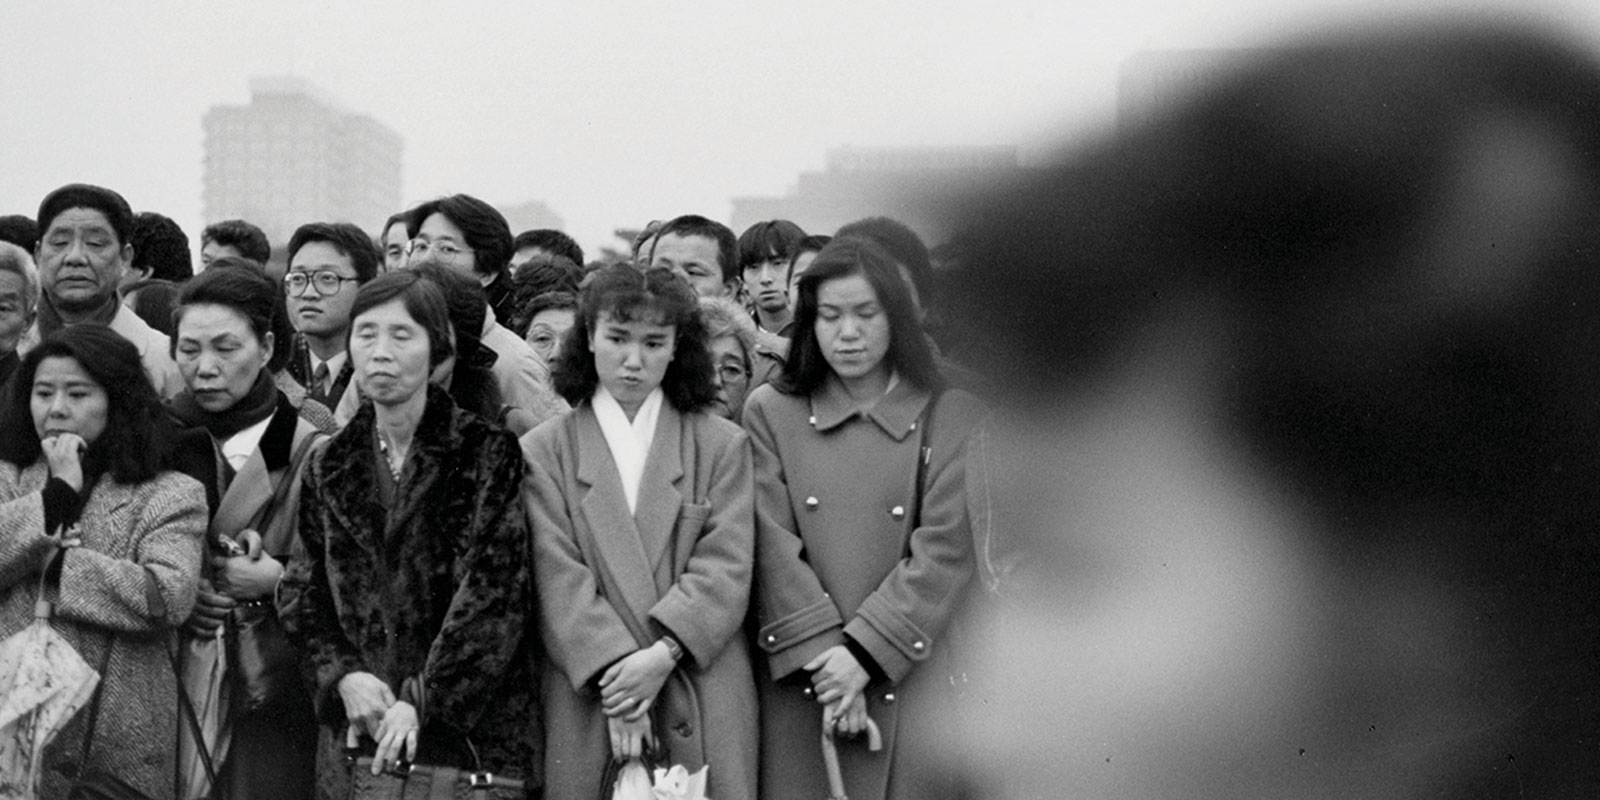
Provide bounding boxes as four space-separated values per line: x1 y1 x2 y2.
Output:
522 403 757 800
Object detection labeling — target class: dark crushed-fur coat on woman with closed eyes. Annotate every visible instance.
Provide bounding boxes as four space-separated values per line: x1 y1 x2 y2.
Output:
278 386 539 786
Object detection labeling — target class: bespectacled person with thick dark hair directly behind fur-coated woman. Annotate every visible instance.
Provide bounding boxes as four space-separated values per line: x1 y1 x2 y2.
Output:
406 194 517 331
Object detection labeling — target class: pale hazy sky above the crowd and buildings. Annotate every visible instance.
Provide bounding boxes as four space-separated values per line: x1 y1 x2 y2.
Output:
0 0 1600 256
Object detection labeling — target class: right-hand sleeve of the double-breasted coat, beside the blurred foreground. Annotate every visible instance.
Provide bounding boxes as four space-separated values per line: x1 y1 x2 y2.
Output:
845 392 978 683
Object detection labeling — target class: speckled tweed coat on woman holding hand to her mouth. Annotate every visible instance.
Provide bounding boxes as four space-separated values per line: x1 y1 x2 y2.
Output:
0 459 206 797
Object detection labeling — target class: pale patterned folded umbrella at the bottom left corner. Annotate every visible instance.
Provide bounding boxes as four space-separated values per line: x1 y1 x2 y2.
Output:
0 563 101 800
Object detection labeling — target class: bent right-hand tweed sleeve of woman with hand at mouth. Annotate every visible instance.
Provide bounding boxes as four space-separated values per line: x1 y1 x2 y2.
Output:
56 472 206 632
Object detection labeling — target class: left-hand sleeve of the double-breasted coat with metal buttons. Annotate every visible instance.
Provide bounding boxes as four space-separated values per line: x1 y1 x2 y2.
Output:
744 387 845 680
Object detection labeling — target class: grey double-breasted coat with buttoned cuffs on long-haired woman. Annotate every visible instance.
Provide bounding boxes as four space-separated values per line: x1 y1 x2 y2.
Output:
744 376 982 800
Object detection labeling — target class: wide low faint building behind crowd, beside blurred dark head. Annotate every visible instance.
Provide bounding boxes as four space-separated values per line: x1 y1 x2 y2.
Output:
731 147 1022 245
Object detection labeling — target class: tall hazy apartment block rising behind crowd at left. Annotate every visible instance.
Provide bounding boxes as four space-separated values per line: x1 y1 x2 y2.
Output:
203 77 403 248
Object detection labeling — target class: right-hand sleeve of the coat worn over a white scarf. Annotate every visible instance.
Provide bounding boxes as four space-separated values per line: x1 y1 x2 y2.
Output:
650 422 755 666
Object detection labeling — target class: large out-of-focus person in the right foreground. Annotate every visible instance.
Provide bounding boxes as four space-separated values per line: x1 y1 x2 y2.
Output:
930 21 1600 798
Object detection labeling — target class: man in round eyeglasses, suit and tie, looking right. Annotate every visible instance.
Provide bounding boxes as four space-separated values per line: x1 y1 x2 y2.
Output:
283 222 381 410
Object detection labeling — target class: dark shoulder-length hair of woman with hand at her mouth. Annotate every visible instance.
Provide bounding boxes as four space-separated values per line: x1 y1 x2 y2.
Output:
0 323 171 488
